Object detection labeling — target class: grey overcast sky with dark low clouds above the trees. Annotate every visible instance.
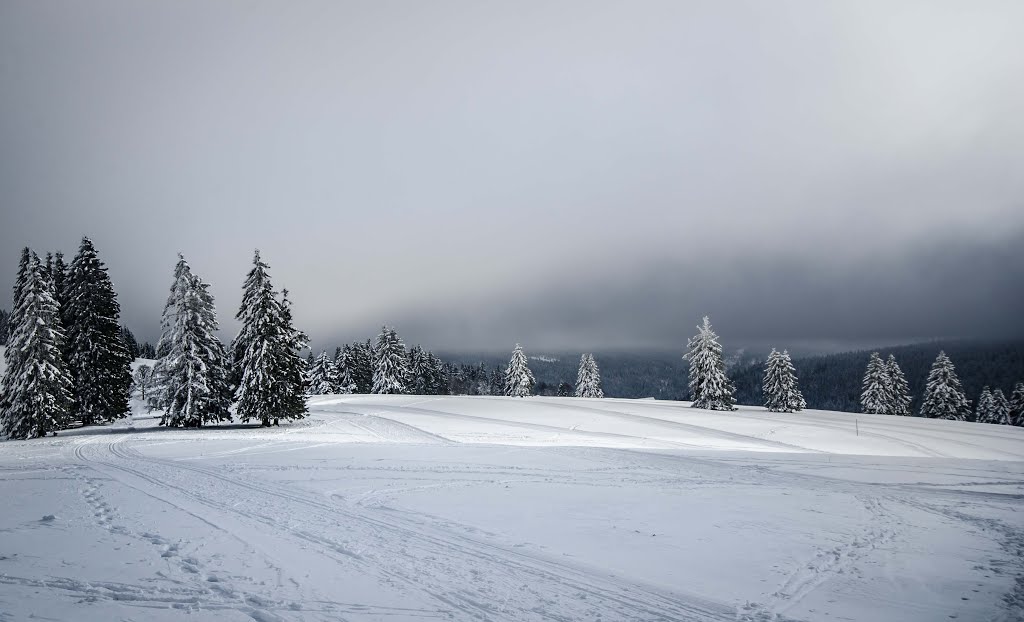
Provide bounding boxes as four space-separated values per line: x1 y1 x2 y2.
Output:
0 0 1024 351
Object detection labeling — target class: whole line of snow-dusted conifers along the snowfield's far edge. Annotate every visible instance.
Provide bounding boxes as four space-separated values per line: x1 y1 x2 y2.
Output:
0 238 1024 439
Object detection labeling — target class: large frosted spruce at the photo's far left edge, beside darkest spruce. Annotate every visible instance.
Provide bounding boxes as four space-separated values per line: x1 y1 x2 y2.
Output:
0 253 72 439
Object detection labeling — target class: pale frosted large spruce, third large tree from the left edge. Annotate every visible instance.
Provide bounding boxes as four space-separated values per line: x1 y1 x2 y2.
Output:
154 255 231 427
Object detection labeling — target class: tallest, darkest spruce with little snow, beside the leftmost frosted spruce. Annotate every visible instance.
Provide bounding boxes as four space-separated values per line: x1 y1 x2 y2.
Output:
61 238 132 425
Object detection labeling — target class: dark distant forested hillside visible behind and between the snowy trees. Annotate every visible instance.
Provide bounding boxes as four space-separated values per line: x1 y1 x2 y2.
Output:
438 340 1024 414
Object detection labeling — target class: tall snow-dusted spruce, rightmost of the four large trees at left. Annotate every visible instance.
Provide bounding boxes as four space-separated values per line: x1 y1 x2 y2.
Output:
231 251 306 426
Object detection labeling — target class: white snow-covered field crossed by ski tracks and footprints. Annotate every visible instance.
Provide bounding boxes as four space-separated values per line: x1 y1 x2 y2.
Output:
0 396 1024 622
